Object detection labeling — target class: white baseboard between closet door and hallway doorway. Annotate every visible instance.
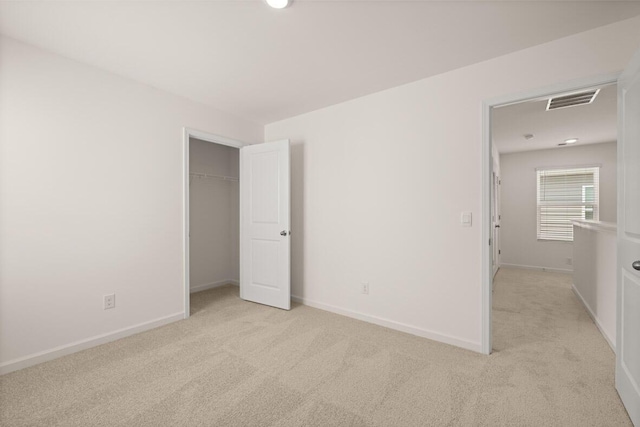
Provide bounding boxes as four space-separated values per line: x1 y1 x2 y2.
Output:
291 295 482 353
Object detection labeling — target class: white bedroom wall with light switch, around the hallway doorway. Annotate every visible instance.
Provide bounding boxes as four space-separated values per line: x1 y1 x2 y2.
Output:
265 18 640 350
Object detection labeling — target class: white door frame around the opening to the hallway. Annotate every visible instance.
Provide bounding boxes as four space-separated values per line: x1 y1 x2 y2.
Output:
480 72 620 354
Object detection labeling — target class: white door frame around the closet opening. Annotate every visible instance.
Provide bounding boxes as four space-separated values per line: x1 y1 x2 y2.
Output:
182 127 249 319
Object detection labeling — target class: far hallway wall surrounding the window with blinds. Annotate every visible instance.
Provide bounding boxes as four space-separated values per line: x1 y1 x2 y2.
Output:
500 142 617 271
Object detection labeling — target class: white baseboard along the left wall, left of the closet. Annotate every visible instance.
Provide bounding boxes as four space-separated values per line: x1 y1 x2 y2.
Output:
0 312 184 375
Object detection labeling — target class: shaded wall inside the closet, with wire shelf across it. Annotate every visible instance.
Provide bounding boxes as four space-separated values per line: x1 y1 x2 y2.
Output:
189 138 240 291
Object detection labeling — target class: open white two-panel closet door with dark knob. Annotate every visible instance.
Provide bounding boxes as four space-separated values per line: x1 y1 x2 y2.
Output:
240 140 291 310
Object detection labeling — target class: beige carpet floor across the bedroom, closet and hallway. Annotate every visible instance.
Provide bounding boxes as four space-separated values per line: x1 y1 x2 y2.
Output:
0 269 631 427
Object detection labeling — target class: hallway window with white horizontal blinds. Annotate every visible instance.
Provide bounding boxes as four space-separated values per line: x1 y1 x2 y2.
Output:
536 167 600 242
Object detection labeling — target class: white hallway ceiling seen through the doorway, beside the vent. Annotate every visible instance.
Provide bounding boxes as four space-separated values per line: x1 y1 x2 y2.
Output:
491 85 618 154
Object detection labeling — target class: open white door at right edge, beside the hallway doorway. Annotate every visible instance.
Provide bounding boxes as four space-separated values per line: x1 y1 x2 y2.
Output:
616 51 640 426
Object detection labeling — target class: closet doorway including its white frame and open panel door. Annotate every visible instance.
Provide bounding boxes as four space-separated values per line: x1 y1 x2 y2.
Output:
183 128 291 319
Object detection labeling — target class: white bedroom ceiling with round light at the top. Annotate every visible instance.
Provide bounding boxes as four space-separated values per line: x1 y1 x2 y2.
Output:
0 0 640 123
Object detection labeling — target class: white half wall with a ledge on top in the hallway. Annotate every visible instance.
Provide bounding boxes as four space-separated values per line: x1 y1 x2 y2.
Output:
573 221 618 352
